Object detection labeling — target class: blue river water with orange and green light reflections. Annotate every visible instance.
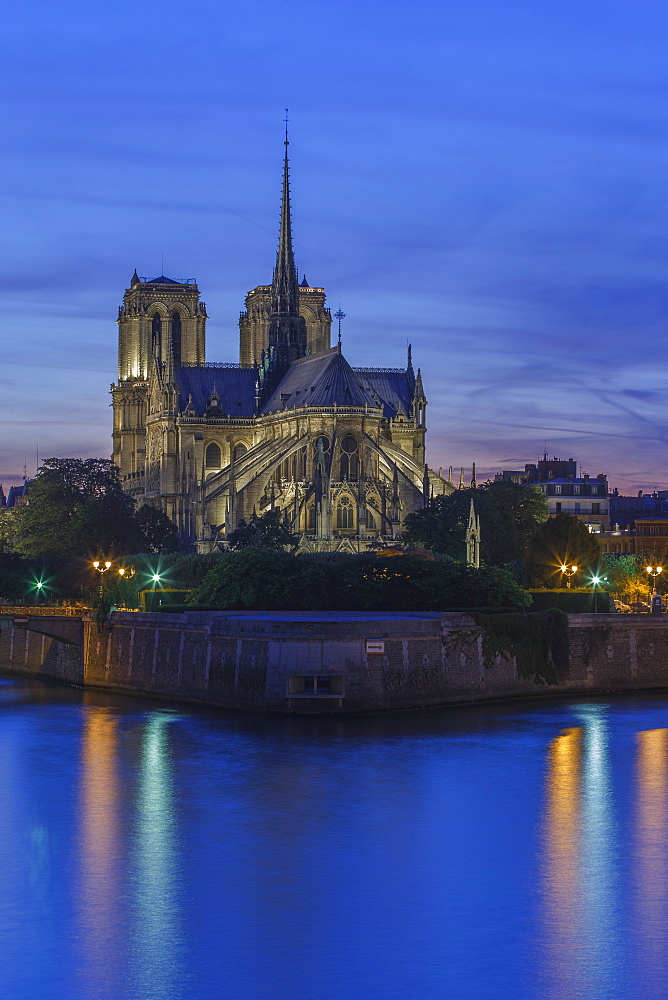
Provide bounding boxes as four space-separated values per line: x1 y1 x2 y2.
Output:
0 677 668 1000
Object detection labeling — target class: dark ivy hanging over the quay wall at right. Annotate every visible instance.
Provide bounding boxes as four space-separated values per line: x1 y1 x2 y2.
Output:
474 611 568 684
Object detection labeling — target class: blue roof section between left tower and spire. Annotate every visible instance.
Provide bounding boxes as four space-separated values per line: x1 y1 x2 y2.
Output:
176 364 256 417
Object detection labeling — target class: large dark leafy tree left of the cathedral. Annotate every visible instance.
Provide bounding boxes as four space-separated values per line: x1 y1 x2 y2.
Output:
17 458 141 558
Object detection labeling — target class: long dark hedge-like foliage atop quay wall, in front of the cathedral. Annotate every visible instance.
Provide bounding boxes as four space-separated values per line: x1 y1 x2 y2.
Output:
191 547 530 611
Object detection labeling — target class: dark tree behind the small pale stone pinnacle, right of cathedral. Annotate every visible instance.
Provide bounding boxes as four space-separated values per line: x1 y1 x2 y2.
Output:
404 482 547 566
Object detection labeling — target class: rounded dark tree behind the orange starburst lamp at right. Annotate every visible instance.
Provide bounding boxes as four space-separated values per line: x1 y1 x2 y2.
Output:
527 514 602 587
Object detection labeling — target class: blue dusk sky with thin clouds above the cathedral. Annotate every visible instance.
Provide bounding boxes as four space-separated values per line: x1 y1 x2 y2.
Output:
0 0 668 493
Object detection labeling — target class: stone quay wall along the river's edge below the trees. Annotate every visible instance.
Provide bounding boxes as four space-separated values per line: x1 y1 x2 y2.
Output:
0 611 668 713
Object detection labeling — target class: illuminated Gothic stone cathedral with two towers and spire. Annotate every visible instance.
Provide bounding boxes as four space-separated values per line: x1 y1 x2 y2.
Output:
111 135 453 552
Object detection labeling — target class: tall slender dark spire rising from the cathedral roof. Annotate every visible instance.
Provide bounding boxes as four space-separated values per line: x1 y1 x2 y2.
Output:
269 115 306 371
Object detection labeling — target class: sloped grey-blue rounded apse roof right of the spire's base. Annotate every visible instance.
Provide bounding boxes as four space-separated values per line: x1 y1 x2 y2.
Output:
263 347 379 413
